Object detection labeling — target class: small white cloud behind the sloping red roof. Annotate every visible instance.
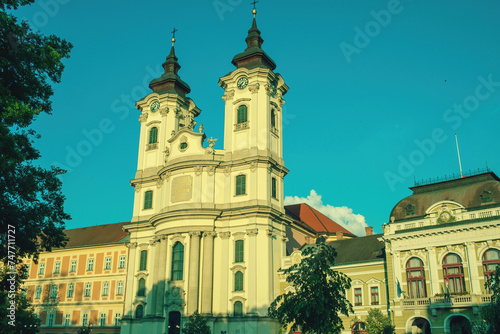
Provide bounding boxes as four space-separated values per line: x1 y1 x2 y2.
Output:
285 189 368 236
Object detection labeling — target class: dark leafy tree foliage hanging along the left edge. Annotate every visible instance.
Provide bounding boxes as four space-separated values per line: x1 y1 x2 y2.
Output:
0 0 72 262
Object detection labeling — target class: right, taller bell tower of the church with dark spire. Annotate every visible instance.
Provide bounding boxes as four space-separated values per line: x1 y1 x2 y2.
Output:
219 8 288 166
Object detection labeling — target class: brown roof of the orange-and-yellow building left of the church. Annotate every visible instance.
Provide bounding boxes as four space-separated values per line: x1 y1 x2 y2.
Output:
59 222 128 248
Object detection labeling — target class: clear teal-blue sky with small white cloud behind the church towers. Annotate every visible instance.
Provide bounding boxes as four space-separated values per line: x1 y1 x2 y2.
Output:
13 0 500 232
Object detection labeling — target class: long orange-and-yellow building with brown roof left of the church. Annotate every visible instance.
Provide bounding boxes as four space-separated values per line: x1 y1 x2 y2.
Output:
24 223 128 334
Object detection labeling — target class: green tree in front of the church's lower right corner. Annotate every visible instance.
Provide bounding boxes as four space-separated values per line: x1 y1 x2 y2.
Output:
269 237 353 334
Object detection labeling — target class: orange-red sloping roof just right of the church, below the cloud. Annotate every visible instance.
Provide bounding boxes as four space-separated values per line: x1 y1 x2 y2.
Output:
285 203 356 237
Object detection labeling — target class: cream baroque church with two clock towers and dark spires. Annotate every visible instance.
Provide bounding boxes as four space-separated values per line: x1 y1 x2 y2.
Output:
121 10 293 333
